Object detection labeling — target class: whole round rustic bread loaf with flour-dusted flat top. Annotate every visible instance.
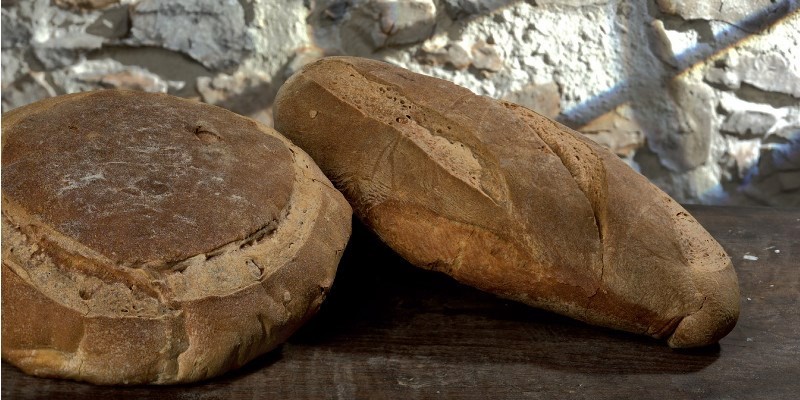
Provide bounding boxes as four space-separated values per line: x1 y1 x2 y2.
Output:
2 90 352 384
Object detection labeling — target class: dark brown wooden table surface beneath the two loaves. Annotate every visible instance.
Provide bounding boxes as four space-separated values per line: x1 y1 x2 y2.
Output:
2 206 800 399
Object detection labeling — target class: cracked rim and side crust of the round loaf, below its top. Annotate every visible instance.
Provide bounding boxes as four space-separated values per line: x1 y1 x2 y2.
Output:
2 90 351 384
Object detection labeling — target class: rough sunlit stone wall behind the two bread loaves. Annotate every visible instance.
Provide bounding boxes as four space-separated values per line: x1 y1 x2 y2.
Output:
2 0 800 207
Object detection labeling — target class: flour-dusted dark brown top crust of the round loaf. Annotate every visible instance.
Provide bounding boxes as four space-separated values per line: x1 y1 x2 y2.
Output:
2 91 293 268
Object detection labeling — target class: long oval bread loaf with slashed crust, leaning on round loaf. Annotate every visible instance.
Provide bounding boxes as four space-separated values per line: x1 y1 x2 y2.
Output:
274 57 739 347
